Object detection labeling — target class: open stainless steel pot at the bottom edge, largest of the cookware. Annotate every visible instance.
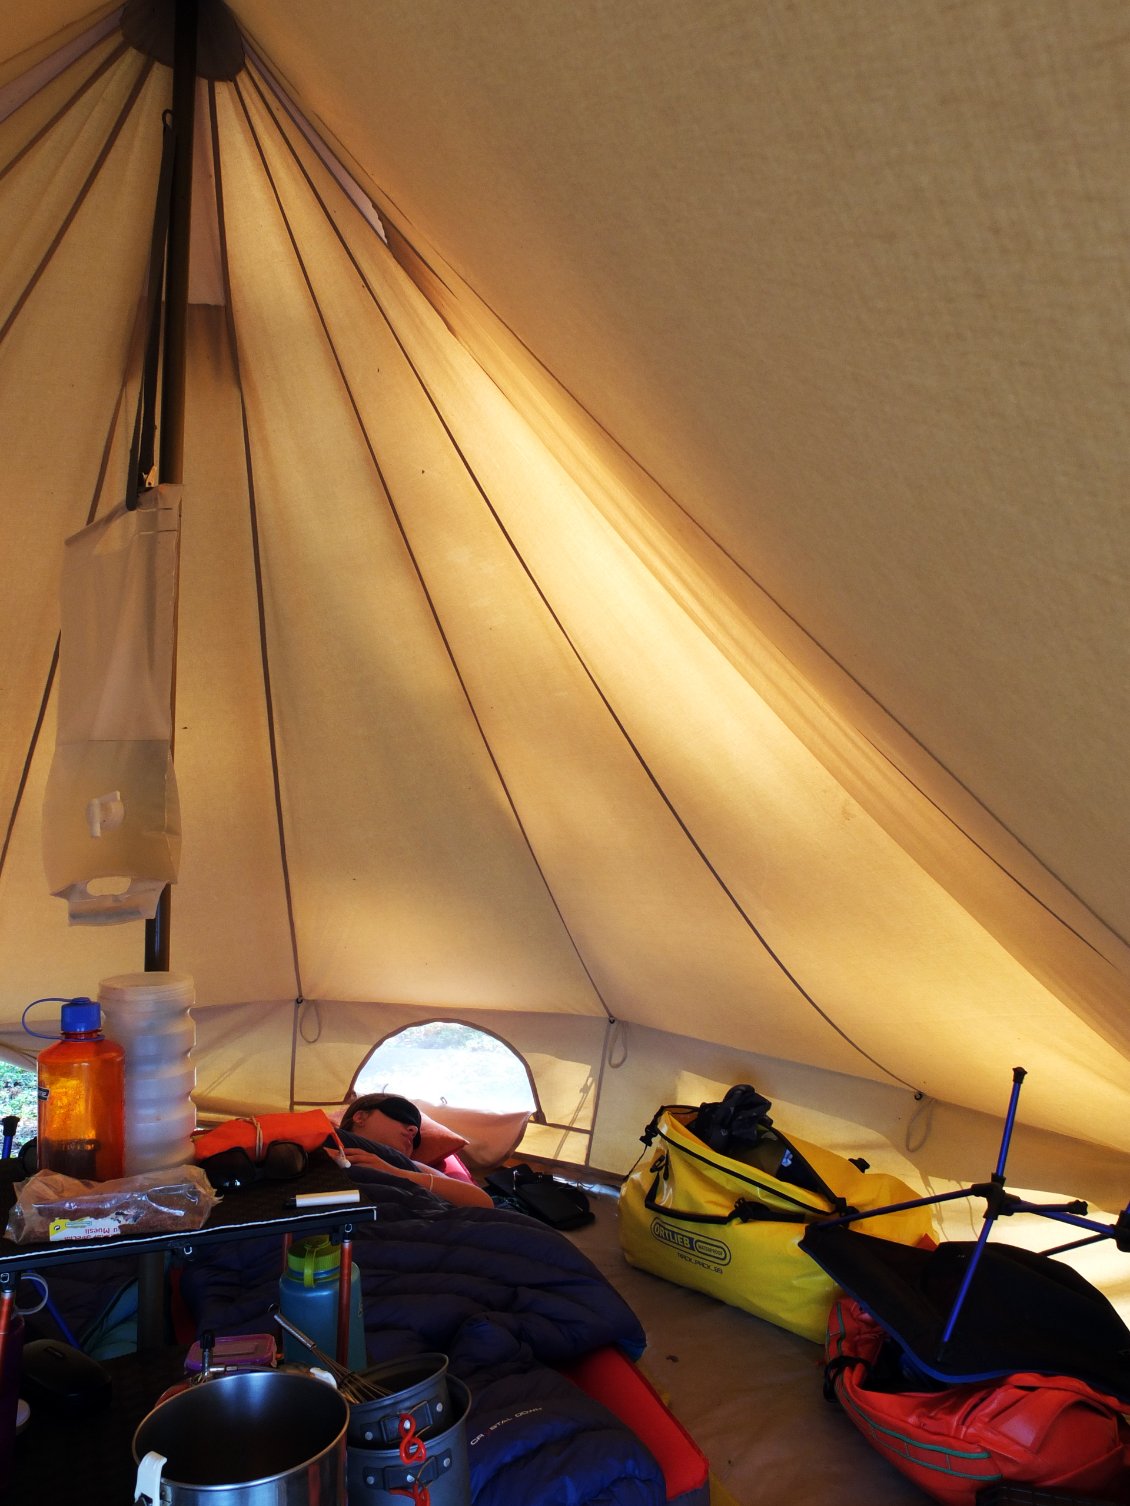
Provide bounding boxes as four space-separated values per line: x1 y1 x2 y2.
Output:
133 1370 350 1506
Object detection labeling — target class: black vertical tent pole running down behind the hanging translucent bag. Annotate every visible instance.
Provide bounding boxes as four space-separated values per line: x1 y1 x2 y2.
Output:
145 0 197 973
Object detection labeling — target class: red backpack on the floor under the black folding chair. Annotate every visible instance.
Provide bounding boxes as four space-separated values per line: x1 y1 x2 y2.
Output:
824 1297 1130 1506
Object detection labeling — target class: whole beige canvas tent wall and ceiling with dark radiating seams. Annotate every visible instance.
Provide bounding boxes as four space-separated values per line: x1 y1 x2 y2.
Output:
0 0 1130 1192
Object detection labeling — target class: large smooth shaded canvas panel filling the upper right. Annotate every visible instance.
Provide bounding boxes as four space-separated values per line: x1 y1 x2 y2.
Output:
238 0 1127 931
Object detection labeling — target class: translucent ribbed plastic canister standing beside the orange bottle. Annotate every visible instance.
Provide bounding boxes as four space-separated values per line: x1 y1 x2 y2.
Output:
98 971 196 1176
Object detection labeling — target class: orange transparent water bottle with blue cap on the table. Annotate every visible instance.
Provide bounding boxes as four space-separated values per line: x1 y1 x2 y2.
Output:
38 998 125 1182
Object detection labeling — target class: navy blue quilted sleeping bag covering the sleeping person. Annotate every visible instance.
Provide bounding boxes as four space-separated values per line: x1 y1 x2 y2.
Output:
181 1167 666 1506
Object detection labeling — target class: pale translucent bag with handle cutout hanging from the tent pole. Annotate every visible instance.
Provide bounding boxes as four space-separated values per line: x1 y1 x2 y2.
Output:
44 486 181 925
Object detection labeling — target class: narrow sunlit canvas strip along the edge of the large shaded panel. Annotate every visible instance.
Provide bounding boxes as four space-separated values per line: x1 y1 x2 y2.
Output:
381 226 1127 1060
